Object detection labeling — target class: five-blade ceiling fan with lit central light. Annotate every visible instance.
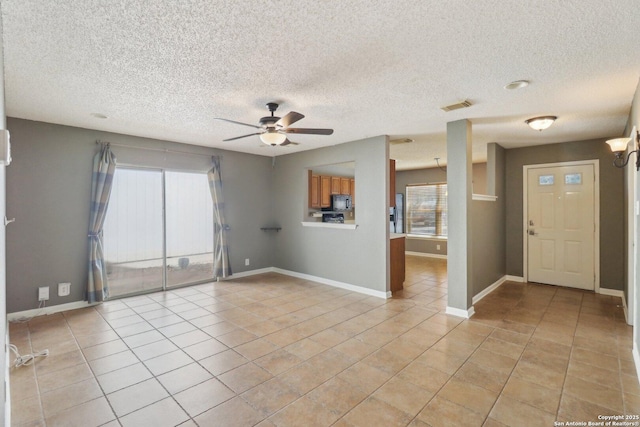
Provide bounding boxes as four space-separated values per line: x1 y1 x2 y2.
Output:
214 102 333 146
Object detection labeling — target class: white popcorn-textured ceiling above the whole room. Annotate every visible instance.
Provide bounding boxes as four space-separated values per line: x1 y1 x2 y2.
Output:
1 0 640 169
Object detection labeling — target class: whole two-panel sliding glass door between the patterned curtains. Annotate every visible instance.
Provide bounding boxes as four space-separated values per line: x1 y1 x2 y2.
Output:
104 167 213 297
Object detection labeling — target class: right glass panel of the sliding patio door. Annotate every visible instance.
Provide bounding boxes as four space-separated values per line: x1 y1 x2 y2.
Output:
165 171 213 287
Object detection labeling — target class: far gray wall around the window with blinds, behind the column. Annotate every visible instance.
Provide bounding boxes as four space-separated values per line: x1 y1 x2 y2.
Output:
396 163 487 255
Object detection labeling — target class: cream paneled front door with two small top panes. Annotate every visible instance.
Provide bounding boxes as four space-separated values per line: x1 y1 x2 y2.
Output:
525 164 596 290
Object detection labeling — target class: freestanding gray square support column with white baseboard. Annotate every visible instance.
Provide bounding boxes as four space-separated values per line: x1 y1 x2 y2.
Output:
447 119 473 317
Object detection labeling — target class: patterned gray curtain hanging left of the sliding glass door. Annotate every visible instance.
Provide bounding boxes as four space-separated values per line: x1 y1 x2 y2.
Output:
87 144 116 303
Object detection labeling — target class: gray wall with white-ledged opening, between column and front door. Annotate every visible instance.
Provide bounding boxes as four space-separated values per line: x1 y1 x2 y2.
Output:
471 144 507 296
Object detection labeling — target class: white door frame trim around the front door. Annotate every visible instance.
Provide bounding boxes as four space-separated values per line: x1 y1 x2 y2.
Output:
522 159 600 293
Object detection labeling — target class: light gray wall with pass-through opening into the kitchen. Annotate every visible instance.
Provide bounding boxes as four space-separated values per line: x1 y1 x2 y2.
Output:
273 136 389 292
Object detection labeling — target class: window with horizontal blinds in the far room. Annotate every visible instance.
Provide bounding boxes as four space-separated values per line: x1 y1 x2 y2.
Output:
406 184 448 237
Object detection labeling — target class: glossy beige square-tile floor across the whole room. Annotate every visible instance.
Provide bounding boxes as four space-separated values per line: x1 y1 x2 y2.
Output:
10 256 640 427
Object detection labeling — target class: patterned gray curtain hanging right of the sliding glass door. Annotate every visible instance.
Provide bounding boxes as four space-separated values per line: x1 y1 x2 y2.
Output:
207 156 232 278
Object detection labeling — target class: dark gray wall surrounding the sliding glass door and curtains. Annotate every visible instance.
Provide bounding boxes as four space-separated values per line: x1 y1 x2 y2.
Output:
7 118 274 312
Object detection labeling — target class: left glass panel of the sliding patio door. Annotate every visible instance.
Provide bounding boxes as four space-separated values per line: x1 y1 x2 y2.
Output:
103 168 164 297
